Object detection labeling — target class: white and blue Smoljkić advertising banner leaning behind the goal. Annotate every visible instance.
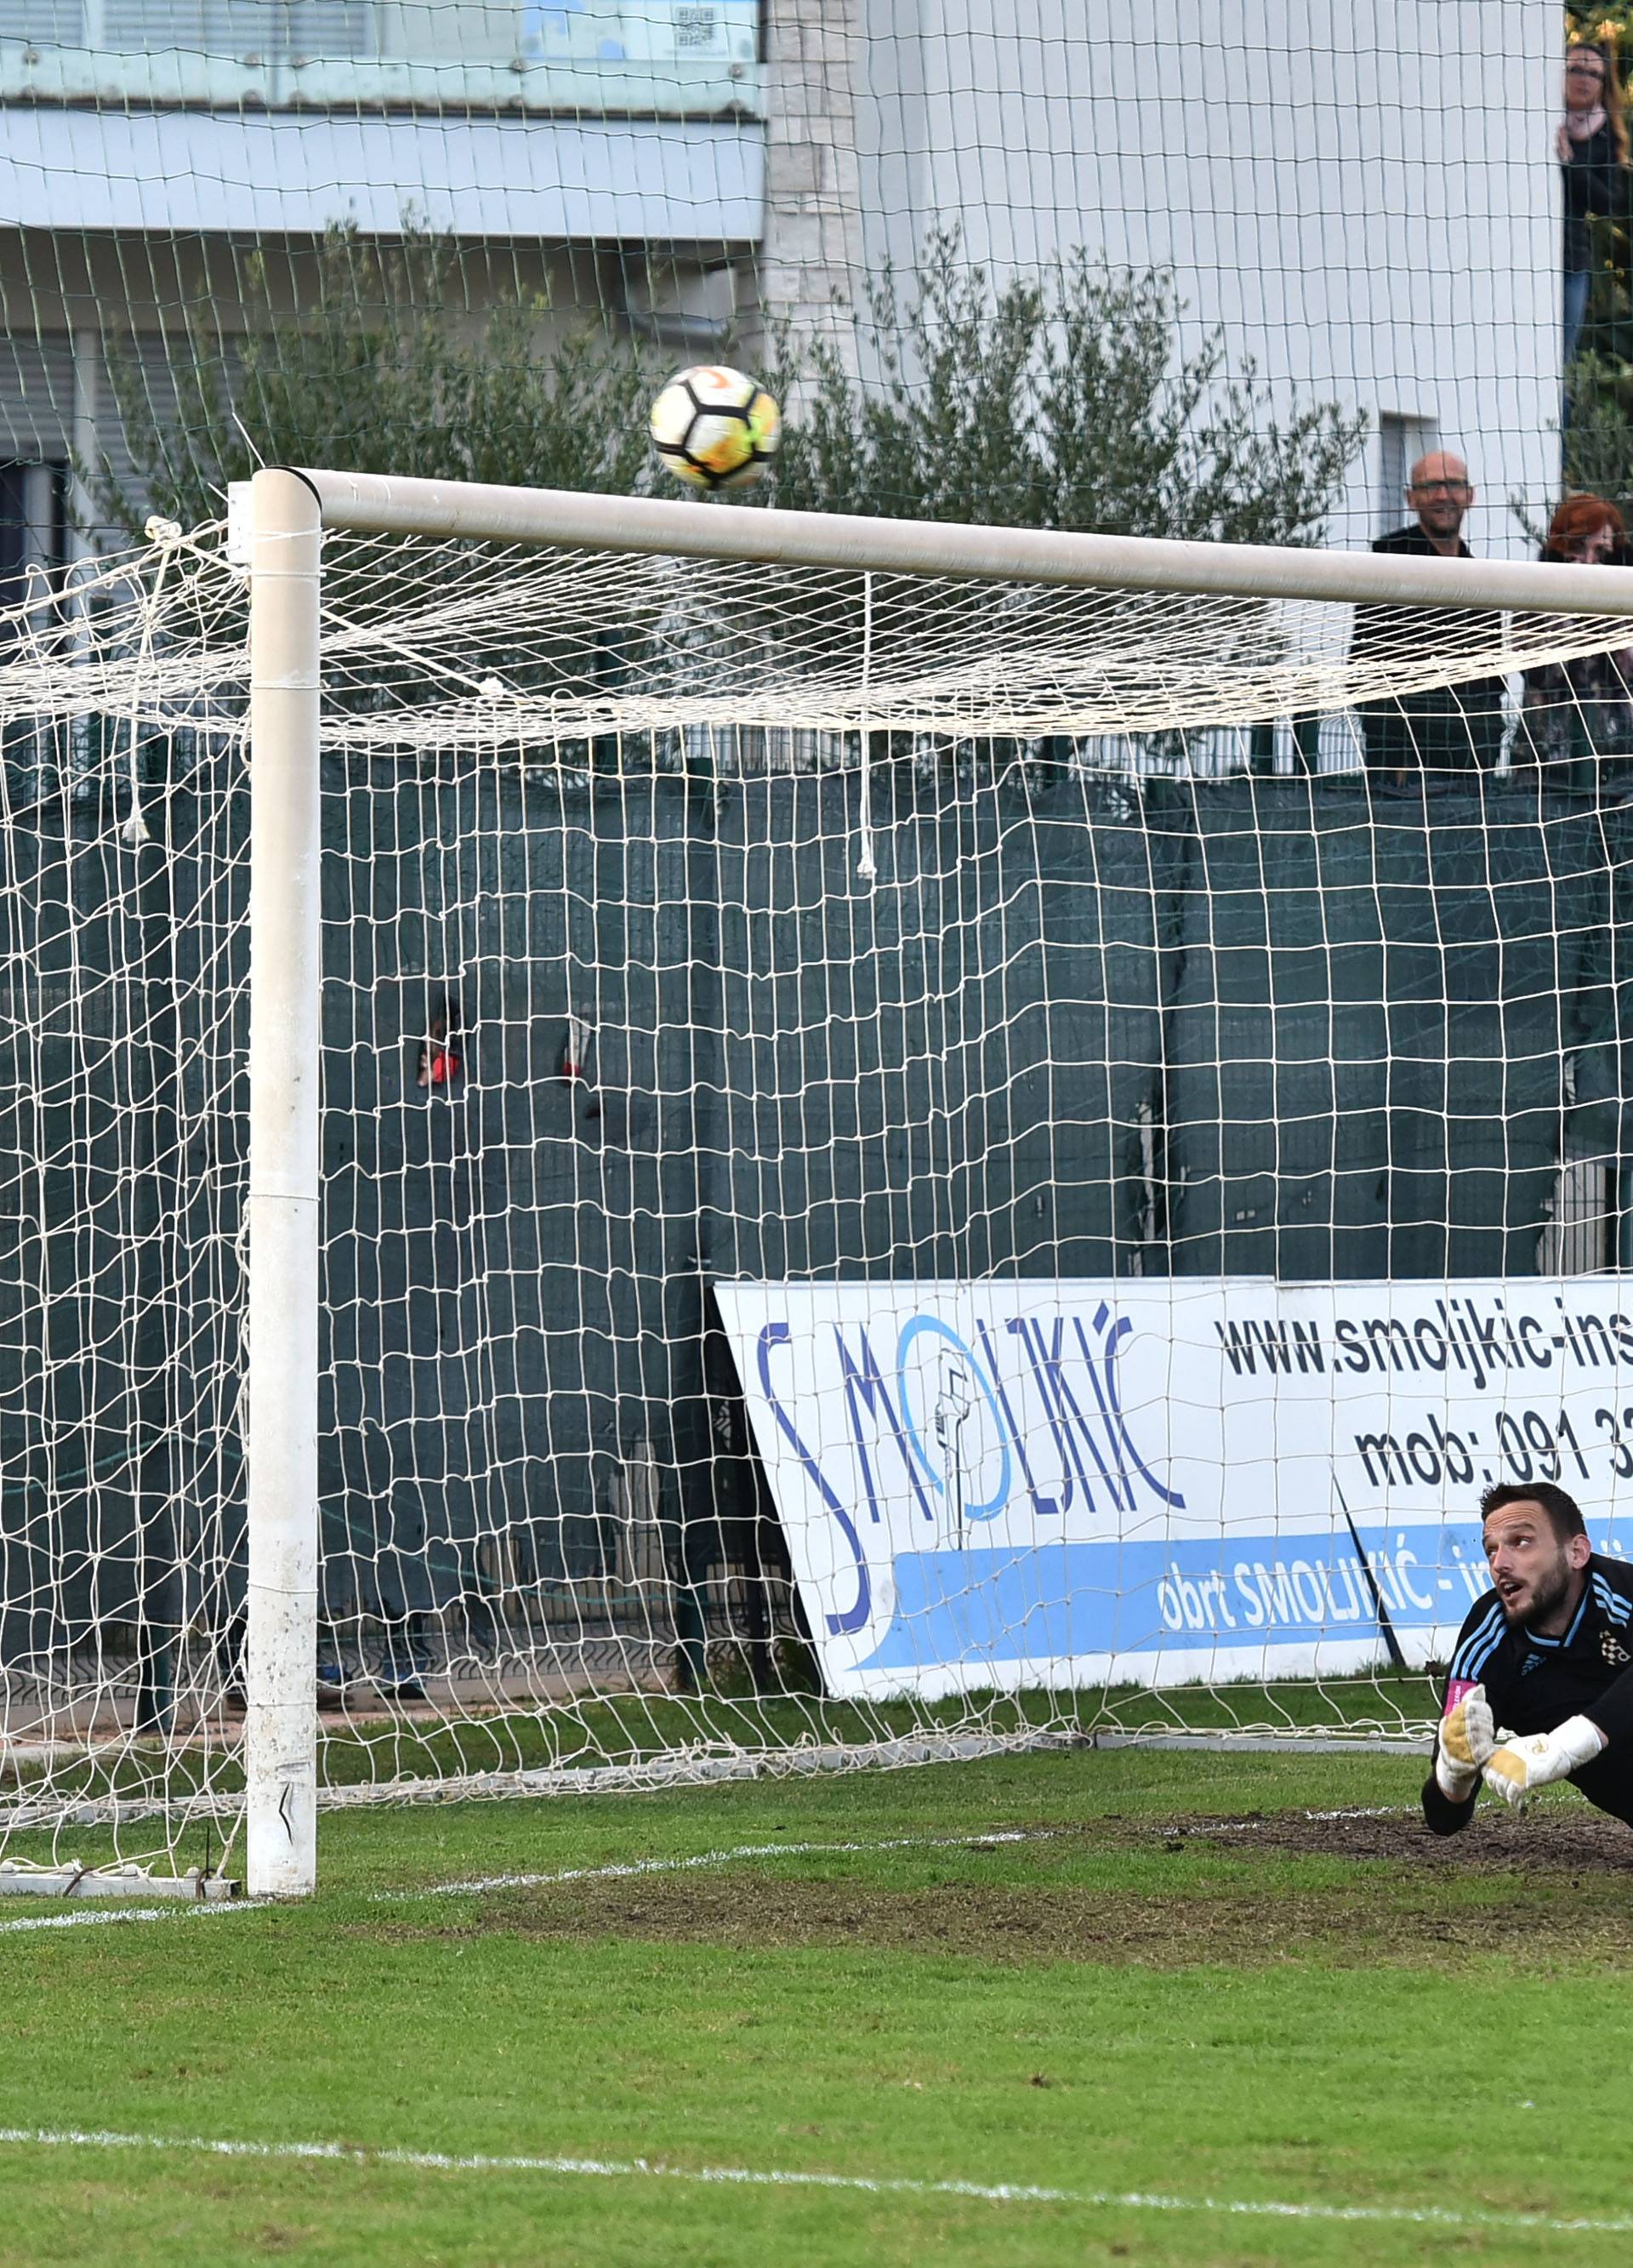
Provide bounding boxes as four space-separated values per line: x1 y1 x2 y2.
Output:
717 1277 1633 1699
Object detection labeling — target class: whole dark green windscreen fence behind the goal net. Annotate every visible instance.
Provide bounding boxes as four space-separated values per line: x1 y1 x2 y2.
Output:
0 753 1633 1654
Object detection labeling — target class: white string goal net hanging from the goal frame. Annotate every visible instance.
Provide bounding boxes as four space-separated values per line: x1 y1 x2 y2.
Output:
0 487 1633 1880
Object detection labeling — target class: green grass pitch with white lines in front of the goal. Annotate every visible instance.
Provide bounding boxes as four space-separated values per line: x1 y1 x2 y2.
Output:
0 1751 1633 2268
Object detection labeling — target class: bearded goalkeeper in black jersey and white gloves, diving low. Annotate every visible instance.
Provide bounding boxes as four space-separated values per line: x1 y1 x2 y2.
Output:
1422 1481 1633 1835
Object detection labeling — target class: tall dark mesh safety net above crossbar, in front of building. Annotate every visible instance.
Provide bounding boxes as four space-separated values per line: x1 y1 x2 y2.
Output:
0 0 1569 576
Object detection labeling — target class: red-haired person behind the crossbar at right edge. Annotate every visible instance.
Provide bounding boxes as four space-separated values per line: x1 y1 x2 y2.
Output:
1515 497 1633 791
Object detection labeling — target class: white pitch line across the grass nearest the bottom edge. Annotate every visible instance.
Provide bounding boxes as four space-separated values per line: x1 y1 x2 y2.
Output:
0 2128 1633 2237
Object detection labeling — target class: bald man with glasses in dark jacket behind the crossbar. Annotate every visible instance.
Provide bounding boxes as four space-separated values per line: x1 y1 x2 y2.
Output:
1350 449 1504 783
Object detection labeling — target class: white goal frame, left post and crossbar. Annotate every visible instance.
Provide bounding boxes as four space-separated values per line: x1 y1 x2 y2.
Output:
232 470 1633 1896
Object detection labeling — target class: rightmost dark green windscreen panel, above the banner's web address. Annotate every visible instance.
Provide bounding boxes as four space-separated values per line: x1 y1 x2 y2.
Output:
1164 780 1624 1281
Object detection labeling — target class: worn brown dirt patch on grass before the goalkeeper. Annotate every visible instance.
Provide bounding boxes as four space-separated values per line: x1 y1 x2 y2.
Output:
376 1808 1633 1969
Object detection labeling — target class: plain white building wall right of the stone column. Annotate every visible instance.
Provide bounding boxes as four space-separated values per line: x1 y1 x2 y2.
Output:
857 0 1565 556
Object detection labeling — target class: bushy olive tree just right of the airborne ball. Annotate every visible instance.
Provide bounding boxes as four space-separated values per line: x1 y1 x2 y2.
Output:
776 229 1368 542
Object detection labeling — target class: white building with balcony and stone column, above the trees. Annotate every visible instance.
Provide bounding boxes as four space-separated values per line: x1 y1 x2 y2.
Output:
0 0 1561 573
